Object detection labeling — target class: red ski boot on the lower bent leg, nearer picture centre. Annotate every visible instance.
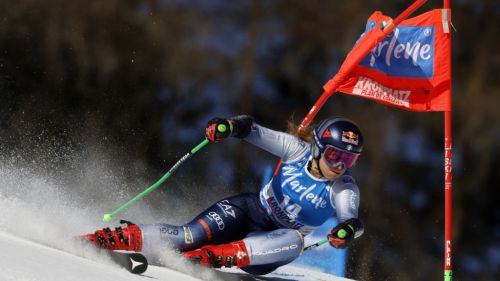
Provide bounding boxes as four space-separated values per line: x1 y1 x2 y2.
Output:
182 240 250 268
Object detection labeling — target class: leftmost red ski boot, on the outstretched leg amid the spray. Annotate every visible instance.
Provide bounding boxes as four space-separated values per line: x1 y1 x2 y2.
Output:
77 220 142 252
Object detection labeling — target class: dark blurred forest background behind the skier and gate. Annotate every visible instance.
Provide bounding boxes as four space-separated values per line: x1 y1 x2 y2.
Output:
0 0 500 281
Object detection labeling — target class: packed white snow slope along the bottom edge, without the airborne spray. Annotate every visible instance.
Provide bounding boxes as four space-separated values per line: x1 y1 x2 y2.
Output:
0 232 356 281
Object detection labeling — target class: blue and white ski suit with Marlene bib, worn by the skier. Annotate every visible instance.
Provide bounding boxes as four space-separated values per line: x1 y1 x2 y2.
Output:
139 123 360 274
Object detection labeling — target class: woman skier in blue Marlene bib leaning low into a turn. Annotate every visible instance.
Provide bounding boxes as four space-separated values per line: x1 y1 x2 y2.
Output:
81 115 364 274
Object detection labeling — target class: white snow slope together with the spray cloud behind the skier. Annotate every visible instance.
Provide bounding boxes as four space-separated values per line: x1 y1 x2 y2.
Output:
0 154 356 281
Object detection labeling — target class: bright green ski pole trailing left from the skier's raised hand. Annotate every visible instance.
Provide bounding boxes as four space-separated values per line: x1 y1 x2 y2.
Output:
102 124 228 222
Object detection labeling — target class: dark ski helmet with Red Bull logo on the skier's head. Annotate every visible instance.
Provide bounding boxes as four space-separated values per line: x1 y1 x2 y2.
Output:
311 117 363 168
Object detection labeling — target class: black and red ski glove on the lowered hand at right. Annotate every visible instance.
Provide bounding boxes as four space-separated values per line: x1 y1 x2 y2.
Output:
327 218 363 249
